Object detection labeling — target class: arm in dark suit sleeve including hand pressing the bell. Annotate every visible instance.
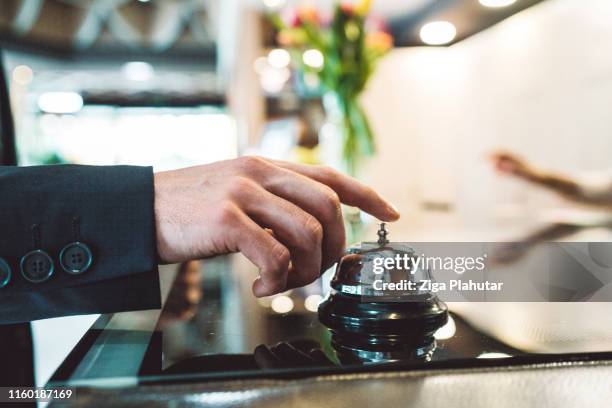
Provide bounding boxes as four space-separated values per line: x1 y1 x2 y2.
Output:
0 157 400 323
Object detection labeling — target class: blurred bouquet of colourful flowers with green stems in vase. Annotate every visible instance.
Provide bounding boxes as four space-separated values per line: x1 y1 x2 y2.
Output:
272 0 393 175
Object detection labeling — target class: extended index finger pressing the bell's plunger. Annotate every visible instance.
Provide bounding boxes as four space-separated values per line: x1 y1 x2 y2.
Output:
274 161 400 221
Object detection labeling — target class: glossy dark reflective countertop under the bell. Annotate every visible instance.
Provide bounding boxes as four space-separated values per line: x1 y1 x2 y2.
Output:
52 255 612 386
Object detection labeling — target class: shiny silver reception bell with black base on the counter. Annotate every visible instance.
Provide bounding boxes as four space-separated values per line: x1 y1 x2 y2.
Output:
318 223 448 363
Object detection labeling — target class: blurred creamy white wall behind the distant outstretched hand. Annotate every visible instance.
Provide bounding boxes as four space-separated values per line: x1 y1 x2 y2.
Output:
363 0 612 239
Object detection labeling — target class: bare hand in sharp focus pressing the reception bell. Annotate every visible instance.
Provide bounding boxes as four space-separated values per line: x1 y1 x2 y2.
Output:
155 157 399 297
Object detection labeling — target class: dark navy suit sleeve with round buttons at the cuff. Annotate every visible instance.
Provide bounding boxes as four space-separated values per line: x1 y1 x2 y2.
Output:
0 165 160 324
